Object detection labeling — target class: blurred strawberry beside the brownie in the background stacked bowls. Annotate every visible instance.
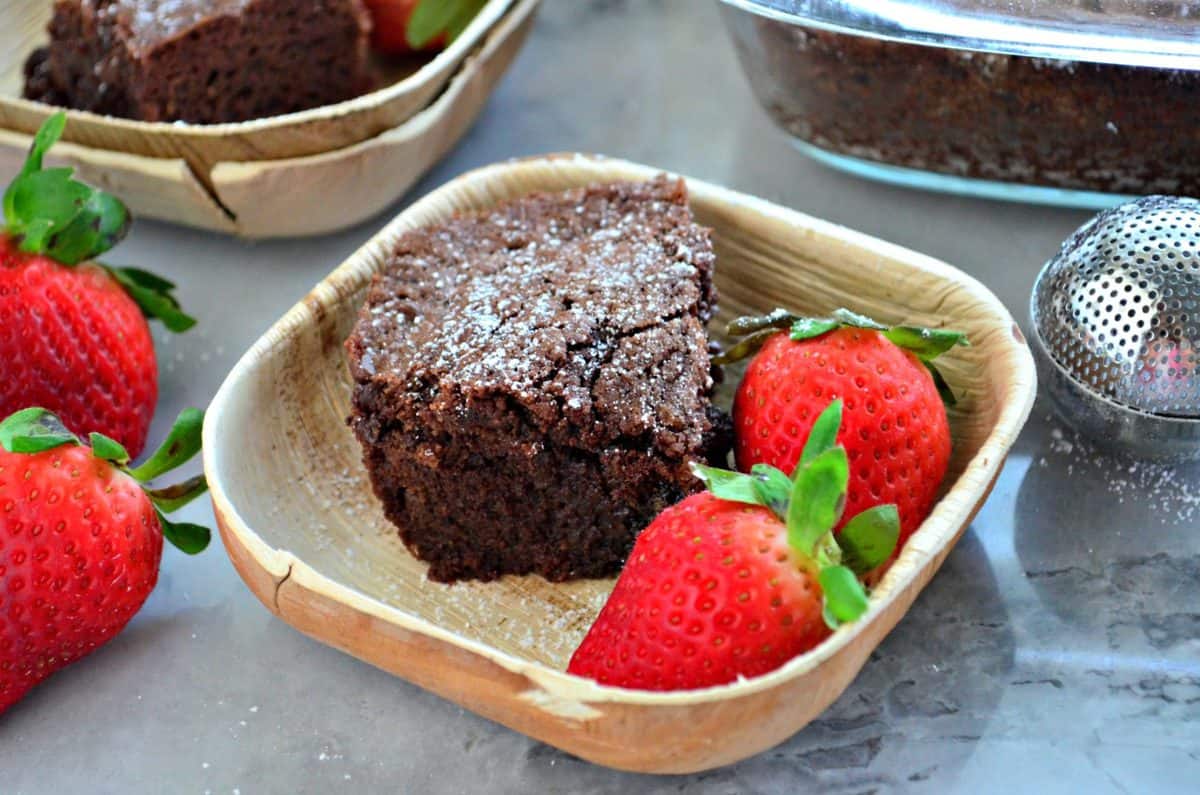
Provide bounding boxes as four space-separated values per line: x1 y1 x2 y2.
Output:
366 0 486 55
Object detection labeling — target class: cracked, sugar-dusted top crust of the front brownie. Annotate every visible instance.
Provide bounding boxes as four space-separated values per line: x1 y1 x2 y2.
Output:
347 177 715 455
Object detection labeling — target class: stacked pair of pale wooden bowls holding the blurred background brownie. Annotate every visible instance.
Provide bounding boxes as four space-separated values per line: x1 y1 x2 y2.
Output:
0 0 539 238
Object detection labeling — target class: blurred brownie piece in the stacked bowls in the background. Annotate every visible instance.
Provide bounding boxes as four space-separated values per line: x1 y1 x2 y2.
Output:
25 0 371 124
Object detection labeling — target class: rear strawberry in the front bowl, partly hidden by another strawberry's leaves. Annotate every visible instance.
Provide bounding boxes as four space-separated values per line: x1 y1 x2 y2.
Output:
731 310 966 545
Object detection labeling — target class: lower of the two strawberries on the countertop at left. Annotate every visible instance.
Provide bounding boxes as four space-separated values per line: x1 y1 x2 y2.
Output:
0 408 209 713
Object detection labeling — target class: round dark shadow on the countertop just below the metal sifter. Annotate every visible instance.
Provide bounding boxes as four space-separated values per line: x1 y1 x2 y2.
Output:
1014 429 1200 665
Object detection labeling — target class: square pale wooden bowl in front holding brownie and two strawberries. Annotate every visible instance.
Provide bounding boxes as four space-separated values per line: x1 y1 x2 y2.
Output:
204 156 1036 772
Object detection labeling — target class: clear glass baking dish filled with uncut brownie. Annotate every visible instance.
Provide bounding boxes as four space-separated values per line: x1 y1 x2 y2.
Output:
722 0 1200 208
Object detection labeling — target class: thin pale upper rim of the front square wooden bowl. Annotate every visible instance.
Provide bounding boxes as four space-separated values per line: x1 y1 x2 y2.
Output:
203 153 1037 707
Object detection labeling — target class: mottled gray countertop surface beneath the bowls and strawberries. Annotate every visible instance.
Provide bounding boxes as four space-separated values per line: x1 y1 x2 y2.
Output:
0 0 1200 795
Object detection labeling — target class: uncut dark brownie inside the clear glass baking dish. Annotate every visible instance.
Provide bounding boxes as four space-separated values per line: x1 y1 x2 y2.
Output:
725 8 1200 196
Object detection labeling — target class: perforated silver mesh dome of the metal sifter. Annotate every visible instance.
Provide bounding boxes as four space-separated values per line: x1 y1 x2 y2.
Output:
1032 196 1200 418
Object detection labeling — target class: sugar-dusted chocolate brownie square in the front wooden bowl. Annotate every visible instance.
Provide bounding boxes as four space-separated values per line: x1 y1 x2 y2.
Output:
346 177 728 581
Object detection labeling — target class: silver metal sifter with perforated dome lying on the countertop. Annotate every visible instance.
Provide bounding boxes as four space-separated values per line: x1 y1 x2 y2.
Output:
1030 196 1200 459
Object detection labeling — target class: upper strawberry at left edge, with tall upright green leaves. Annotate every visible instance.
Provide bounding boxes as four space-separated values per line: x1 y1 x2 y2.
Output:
0 115 194 455
